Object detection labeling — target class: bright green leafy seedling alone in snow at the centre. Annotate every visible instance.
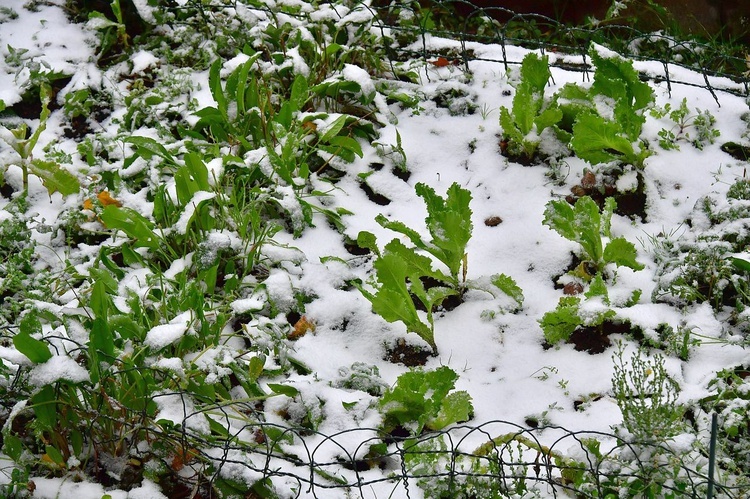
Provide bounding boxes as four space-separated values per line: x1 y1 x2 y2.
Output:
357 183 523 352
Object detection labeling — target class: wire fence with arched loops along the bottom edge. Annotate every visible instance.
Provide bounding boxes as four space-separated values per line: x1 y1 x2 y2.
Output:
157 400 749 499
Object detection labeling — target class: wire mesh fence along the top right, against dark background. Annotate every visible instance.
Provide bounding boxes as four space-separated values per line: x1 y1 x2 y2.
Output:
373 0 750 102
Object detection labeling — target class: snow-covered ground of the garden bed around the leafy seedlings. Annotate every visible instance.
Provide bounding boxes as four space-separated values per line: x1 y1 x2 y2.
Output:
0 0 750 498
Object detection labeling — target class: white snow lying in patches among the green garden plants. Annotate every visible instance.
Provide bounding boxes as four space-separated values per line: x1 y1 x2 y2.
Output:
0 0 750 499
